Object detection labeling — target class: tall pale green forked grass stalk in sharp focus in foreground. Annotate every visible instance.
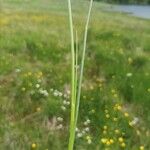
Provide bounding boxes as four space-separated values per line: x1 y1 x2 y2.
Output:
68 0 93 150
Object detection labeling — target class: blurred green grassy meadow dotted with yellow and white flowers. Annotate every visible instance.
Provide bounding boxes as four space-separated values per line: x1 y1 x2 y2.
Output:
0 0 150 150
